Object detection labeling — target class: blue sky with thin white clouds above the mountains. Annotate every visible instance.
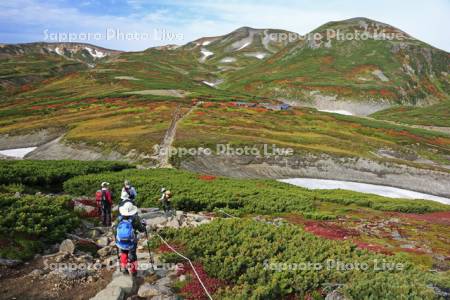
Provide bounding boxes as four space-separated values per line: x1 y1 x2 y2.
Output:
0 0 450 51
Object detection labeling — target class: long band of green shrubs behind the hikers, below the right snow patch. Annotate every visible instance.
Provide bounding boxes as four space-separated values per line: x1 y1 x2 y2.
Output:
64 169 450 213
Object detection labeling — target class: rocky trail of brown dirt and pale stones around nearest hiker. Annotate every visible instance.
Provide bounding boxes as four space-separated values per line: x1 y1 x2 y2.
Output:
0 199 212 300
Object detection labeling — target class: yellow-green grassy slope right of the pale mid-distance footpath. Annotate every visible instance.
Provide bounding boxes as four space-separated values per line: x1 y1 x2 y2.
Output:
175 103 450 163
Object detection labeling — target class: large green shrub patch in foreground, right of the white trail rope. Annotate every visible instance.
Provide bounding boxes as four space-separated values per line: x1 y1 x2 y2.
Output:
162 219 435 299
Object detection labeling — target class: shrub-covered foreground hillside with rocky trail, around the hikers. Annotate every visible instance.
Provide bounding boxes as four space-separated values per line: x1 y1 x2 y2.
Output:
0 166 450 300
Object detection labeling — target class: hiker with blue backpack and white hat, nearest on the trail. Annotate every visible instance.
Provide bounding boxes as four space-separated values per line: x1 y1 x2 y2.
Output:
114 201 146 276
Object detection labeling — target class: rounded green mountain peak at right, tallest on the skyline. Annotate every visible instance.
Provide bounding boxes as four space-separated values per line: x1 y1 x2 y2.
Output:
224 18 450 114
